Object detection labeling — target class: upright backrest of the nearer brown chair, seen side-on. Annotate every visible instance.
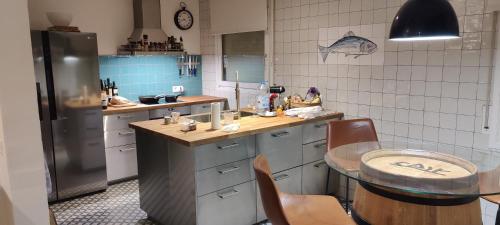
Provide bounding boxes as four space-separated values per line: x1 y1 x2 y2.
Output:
253 154 289 225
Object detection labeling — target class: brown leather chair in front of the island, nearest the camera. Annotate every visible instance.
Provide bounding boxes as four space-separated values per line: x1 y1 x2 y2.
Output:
254 155 355 225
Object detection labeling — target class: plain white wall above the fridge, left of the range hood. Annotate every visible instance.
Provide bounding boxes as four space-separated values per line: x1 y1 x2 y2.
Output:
29 0 134 55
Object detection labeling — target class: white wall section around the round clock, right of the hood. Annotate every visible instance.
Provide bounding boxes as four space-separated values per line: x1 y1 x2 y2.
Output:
161 0 201 55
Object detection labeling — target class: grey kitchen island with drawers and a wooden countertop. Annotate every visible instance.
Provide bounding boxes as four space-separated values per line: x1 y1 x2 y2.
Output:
130 112 343 225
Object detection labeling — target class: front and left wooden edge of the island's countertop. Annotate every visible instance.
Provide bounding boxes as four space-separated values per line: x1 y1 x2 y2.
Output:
129 112 344 147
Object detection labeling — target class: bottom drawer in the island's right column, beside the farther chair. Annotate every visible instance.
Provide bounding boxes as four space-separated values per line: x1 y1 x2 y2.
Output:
302 160 328 195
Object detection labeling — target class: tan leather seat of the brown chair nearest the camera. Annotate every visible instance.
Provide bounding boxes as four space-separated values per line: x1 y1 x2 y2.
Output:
280 193 355 225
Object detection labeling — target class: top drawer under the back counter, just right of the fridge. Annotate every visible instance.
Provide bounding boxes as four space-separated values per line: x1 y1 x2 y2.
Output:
103 111 149 131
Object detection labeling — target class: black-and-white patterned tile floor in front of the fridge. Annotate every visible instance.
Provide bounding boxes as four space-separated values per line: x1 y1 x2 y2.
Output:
51 180 155 225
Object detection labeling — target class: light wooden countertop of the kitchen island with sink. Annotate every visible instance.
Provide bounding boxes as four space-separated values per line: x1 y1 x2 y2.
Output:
129 112 344 147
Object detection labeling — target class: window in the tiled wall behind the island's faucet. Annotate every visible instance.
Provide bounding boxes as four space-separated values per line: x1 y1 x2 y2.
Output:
222 31 265 83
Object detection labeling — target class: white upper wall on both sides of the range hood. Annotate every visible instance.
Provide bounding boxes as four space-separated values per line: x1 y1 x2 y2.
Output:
29 0 200 55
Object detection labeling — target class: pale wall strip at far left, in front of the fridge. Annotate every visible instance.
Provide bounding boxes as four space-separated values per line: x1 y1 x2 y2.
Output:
0 0 49 225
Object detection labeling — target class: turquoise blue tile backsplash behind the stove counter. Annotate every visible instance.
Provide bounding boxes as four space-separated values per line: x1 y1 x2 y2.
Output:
99 56 202 101
